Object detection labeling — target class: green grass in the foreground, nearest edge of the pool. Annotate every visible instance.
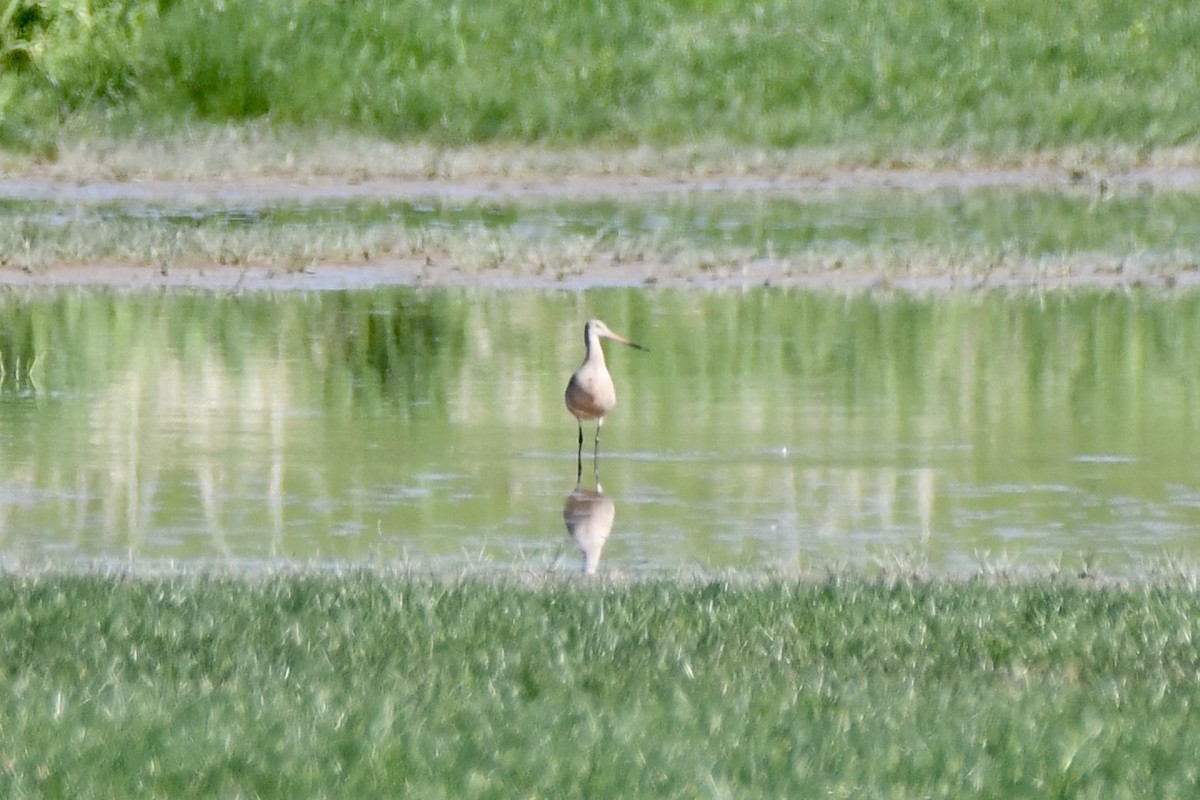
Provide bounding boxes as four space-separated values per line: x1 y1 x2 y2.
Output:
0 573 1200 798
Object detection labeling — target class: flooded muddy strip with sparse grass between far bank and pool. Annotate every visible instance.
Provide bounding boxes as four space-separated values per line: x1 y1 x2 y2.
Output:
7 181 1200 289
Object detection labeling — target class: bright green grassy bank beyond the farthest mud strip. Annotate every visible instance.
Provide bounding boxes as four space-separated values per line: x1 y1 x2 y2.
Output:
0 0 1200 162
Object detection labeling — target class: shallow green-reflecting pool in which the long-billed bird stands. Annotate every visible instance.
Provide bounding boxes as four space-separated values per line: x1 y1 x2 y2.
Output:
0 289 1200 575
